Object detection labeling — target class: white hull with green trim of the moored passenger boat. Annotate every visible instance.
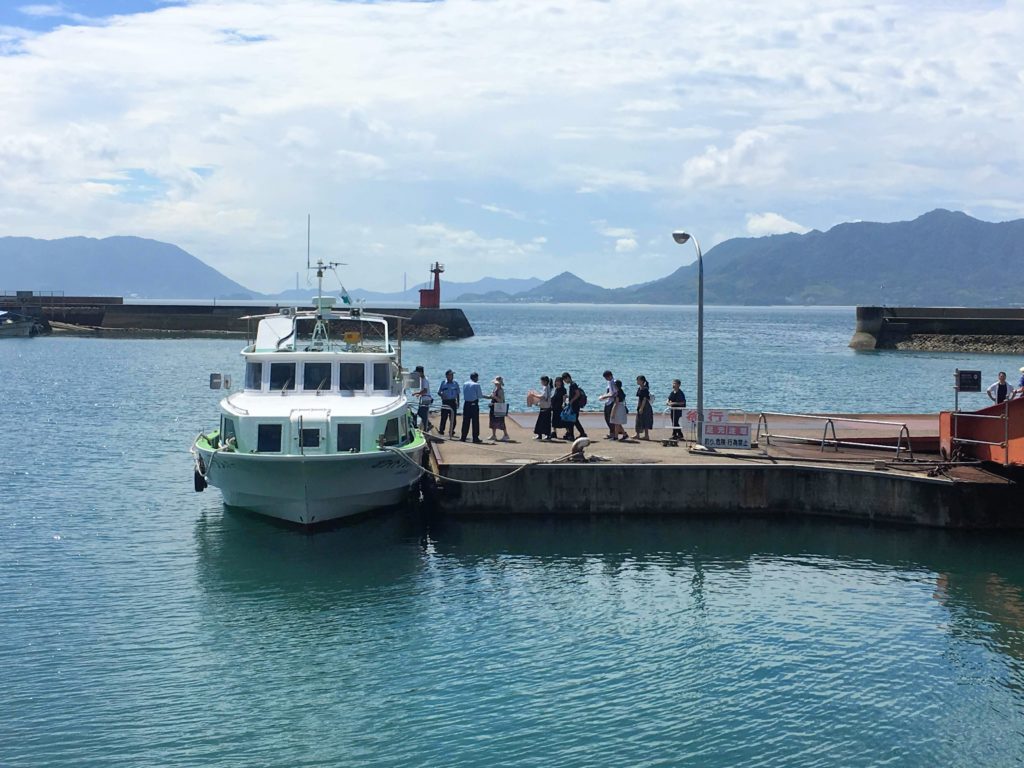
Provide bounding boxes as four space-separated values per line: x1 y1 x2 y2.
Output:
196 440 425 525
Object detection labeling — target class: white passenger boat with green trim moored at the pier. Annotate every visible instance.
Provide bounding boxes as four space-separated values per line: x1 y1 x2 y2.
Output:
193 262 426 525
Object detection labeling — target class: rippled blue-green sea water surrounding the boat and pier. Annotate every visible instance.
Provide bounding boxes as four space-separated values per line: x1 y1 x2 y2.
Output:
0 307 1024 766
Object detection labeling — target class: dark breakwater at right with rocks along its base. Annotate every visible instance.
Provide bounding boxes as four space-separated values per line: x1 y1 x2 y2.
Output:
850 306 1024 354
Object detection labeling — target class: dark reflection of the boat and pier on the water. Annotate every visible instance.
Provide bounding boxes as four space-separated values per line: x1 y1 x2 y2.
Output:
195 509 1024 687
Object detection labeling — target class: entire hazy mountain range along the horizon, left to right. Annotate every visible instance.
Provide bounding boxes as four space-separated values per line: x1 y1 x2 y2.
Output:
0 209 1024 306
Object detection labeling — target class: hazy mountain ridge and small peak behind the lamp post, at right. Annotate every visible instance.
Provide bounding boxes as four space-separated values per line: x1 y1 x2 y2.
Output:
475 210 1024 306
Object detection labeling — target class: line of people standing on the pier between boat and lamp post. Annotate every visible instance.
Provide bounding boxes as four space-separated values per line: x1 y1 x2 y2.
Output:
413 366 686 443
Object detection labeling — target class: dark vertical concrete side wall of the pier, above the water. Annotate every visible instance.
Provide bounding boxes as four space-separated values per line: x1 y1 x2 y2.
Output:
441 463 1024 529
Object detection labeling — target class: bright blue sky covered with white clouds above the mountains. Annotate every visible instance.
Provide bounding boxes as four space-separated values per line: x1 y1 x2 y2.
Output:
0 0 1024 291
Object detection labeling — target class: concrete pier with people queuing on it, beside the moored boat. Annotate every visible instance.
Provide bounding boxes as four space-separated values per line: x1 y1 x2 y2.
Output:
432 414 1024 529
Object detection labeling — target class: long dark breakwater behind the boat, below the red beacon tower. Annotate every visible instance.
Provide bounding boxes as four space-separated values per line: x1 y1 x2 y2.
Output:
0 292 473 341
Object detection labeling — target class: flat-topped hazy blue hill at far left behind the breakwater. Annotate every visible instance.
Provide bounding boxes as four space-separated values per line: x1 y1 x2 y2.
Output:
0 238 258 299
